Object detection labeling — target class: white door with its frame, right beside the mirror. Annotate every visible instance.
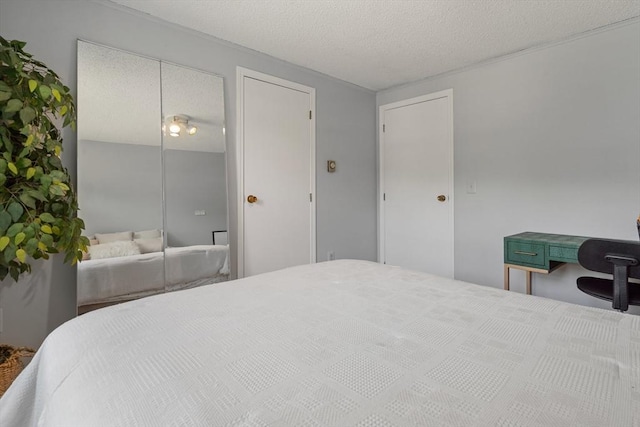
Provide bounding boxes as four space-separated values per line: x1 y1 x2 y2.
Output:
238 68 315 277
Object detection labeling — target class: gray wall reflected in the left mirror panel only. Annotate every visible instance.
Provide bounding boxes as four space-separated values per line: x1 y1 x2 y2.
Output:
77 140 162 236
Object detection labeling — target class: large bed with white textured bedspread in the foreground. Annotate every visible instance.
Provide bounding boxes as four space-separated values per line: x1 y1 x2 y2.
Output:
0 260 640 427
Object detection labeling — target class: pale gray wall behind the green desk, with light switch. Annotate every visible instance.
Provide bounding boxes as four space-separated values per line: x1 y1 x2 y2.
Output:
377 19 640 313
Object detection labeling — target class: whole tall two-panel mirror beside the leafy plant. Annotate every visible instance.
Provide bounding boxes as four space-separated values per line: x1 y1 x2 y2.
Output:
77 41 229 313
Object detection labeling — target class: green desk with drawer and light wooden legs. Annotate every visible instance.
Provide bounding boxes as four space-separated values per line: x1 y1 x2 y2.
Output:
504 231 589 295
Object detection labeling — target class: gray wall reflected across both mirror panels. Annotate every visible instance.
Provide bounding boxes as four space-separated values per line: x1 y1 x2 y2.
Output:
77 140 227 246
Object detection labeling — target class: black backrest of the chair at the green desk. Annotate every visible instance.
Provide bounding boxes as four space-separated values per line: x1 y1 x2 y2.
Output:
578 239 640 279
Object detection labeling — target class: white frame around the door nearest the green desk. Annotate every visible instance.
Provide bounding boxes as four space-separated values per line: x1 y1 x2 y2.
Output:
378 89 455 275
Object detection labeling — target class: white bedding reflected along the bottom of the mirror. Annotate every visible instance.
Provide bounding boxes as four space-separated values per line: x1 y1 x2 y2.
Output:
77 245 229 305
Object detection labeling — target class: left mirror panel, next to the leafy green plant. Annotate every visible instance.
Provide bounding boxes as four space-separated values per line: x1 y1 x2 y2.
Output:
77 41 164 312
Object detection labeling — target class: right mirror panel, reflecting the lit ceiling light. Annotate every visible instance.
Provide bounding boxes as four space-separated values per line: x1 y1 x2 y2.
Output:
161 62 229 290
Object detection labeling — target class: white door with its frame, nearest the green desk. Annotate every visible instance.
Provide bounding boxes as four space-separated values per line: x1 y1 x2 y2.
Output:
378 90 454 277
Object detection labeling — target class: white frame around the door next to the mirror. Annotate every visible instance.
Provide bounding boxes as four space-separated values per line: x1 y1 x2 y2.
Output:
236 67 317 278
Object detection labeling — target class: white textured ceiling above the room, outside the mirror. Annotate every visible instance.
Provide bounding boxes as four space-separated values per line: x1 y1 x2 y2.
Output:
107 0 640 90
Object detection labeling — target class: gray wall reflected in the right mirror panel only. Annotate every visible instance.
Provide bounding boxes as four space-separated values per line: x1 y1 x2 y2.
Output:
164 150 227 246
